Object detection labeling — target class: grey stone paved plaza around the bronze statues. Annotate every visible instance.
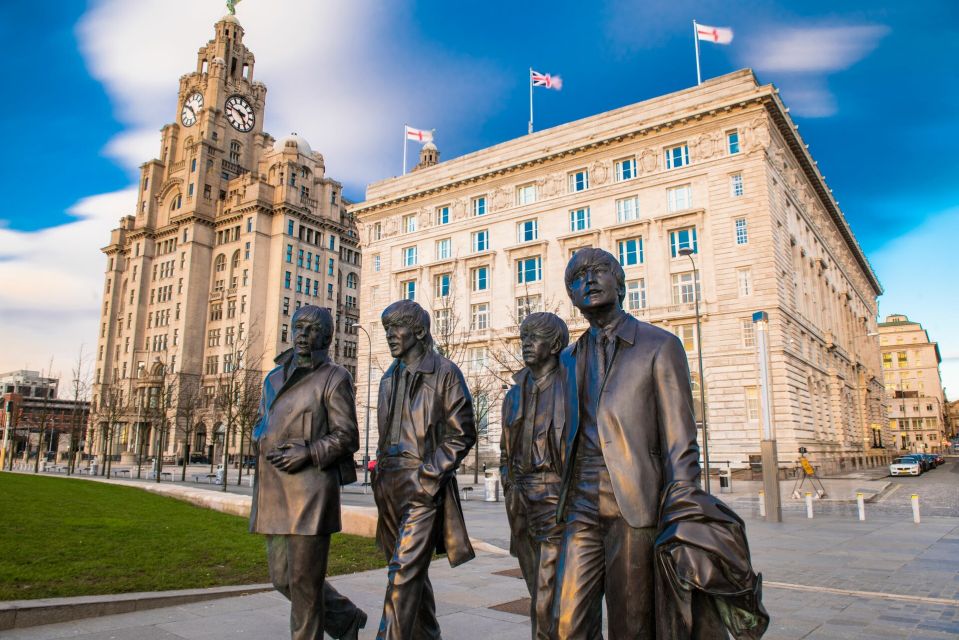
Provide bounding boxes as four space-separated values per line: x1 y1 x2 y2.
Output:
0 462 959 640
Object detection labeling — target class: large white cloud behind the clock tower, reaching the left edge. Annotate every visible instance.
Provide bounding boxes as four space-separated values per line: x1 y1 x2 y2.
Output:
0 0 508 370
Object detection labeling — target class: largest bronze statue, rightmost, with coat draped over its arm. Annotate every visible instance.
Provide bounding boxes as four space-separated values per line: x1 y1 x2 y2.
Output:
553 248 768 640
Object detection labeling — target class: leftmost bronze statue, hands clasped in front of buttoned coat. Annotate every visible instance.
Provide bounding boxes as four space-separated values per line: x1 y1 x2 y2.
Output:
250 305 366 640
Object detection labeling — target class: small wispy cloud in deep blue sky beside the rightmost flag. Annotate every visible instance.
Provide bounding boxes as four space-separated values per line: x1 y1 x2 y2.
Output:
742 25 889 118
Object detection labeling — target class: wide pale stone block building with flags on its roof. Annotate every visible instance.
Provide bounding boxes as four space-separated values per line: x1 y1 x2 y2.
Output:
351 70 892 478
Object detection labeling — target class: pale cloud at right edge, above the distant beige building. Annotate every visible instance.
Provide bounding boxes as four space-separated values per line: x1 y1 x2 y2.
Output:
870 208 959 398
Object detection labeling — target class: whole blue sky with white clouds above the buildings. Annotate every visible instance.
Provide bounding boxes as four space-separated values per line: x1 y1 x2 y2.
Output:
0 0 959 396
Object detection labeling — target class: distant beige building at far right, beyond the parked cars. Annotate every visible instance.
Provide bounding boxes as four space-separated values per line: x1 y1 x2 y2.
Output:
879 314 948 452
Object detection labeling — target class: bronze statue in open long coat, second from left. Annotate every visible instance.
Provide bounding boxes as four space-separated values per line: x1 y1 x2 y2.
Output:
372 300 476 640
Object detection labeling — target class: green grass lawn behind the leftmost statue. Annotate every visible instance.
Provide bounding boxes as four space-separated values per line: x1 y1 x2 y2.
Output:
0 473 386 600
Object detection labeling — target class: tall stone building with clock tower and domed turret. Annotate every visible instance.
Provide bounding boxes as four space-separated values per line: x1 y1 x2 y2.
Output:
88 16 360 462
